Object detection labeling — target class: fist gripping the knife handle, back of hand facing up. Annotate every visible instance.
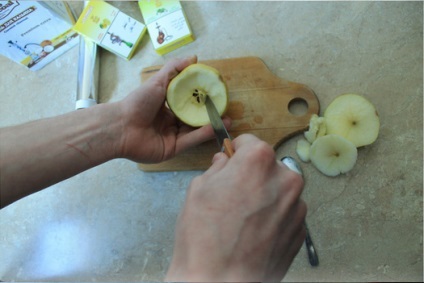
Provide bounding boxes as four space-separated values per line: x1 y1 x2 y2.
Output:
166 135 306 282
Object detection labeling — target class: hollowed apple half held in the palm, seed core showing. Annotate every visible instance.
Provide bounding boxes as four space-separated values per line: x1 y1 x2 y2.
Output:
166 63 228 127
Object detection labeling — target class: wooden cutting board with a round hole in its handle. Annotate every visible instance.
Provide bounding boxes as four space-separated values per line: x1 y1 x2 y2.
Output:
139 57 319 171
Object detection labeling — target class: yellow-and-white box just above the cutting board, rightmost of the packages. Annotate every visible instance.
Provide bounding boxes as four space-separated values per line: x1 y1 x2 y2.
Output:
138 0 194 55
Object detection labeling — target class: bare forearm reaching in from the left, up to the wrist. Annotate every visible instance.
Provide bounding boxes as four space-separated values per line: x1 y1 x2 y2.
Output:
0 103 122 208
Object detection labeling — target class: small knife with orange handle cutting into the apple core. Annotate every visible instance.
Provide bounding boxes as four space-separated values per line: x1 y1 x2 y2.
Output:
205 95 234 157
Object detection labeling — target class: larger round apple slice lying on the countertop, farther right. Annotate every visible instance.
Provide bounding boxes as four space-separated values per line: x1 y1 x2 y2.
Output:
324 94 380 147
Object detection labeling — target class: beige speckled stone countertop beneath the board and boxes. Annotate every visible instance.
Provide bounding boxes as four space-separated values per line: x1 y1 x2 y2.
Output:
0 1 423 282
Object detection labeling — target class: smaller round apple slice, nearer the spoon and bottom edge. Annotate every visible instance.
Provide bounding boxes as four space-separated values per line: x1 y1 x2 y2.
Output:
309 134 358 177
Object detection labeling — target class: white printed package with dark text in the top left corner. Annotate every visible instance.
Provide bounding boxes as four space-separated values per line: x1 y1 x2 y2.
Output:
0 1 79 71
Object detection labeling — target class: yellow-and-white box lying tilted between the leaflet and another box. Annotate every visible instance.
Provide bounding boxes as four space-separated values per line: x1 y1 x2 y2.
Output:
74 1 146 60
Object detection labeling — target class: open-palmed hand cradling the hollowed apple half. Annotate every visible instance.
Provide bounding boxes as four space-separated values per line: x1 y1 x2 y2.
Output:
114 56 231 163
